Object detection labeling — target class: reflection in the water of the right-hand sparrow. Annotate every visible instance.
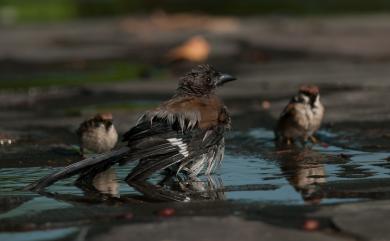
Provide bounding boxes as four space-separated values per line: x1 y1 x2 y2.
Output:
279 149 326 204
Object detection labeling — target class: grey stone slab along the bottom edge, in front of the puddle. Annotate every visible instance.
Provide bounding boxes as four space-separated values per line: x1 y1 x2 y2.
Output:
91 217 351 241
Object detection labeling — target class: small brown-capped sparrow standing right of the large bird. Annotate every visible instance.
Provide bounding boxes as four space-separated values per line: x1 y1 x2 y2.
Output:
275 85 325 145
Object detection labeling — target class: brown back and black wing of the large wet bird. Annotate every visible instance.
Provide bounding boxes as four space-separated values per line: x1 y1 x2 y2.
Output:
123 97 230 179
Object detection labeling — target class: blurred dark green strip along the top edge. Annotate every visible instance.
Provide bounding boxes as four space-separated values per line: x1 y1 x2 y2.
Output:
0 0 390 24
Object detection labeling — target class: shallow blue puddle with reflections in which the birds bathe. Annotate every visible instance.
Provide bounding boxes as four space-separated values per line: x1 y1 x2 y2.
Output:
0 112 390 235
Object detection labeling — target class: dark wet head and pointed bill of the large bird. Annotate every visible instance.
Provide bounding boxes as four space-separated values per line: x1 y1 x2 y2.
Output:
177 64 236 96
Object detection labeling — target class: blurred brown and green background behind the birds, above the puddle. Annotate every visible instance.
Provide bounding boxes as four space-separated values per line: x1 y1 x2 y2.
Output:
0 0 390 153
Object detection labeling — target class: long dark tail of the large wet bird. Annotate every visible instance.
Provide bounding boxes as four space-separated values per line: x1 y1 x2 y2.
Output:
24 147 129 191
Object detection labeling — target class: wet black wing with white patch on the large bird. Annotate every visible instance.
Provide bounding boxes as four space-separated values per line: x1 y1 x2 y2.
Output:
124 118 224 180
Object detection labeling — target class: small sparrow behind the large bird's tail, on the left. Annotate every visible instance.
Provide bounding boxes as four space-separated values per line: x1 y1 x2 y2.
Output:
77 113 118 155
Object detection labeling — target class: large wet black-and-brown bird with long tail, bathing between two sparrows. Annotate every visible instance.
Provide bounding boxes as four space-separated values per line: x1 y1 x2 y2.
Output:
25 64 236 192
